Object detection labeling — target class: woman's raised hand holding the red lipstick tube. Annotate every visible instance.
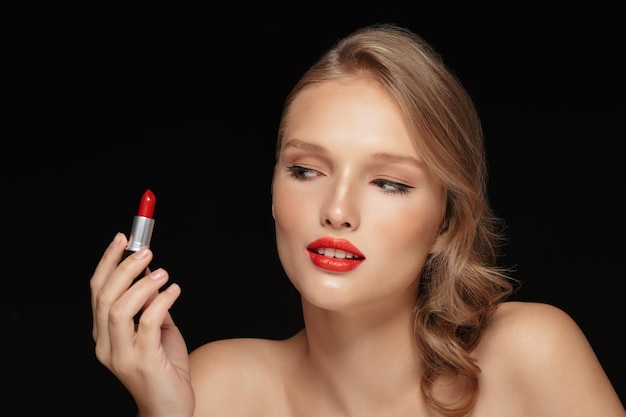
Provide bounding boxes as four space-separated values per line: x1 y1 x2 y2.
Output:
90 233 195 417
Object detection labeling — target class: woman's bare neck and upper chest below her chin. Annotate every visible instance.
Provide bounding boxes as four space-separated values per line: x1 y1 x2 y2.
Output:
302 300 420 415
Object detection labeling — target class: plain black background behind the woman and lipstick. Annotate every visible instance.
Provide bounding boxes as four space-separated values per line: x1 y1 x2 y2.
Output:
0 2 626 416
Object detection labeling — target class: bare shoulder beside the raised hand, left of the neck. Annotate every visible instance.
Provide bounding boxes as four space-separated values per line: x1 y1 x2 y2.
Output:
189 335 299 416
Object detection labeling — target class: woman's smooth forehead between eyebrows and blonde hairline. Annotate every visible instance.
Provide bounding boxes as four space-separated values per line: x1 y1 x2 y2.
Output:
283 78 416 156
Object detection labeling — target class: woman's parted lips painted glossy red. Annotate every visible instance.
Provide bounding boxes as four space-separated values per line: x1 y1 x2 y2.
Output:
307 237 365 272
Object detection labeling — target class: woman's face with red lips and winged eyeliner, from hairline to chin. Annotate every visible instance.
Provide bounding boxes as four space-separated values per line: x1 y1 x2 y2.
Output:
272 79 445 310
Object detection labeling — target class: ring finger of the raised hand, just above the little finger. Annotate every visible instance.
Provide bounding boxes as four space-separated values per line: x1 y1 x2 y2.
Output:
108 268 168 351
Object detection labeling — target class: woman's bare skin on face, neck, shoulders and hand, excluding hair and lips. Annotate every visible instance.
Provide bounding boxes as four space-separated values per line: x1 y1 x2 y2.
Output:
91 78 626 417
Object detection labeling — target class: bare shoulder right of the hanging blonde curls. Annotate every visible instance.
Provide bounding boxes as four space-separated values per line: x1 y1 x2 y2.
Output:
475 302 626 417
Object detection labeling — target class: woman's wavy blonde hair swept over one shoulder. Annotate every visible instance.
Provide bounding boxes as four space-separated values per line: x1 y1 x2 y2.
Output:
277 24 514 417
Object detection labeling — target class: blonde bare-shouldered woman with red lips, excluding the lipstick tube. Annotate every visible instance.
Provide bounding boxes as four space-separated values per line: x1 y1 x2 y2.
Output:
91 25 626 417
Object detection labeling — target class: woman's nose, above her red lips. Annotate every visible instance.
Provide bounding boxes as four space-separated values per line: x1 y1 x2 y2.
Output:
320 183 359 230
